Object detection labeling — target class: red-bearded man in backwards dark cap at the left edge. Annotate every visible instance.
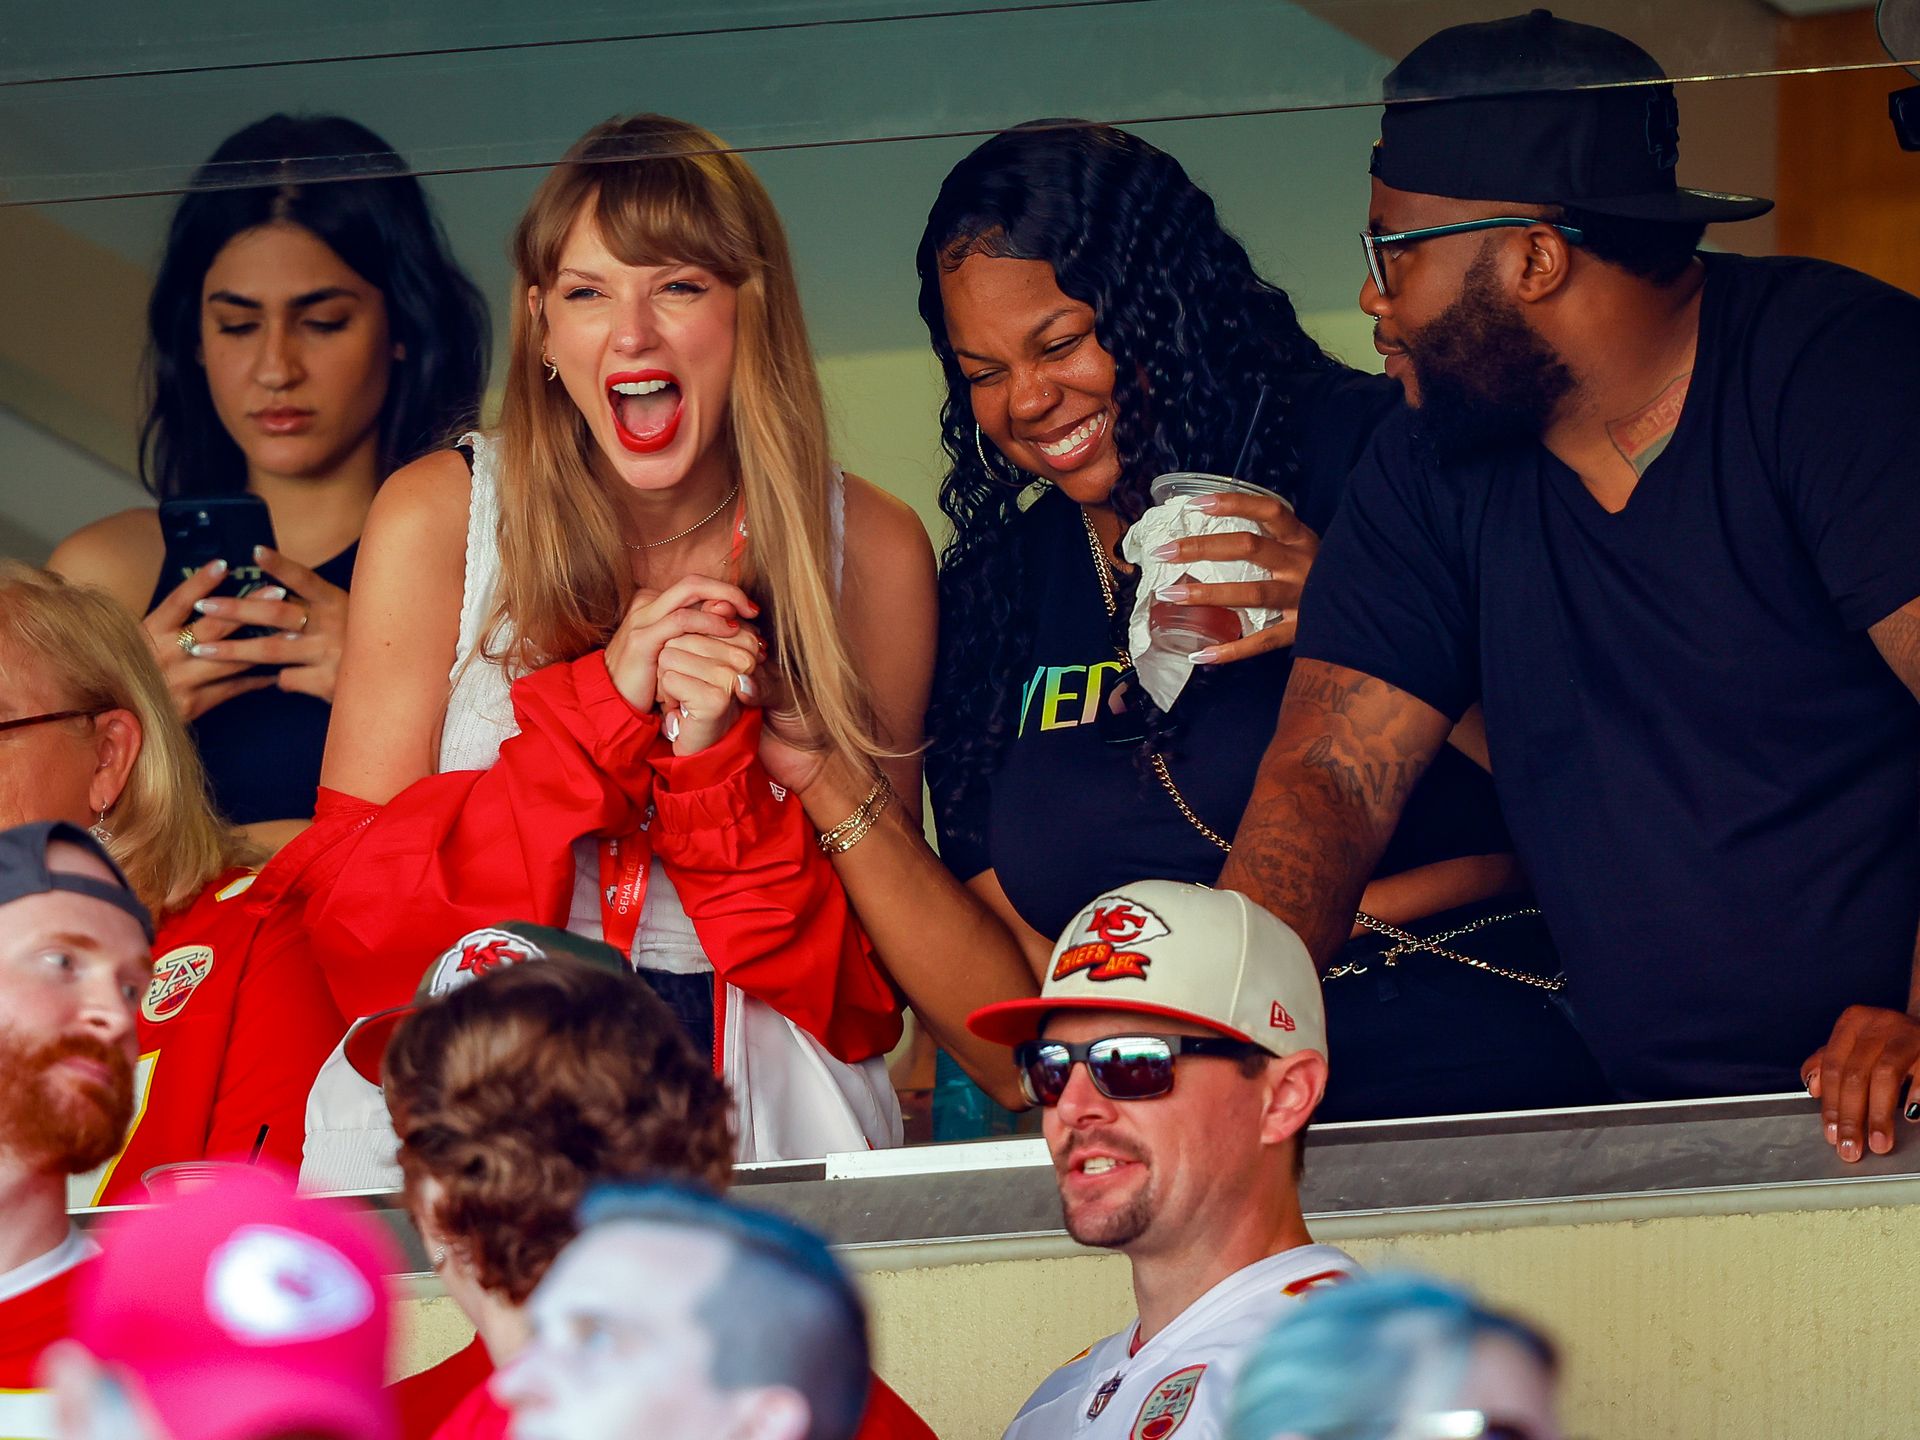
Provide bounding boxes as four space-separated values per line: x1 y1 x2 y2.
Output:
0 822 154 1440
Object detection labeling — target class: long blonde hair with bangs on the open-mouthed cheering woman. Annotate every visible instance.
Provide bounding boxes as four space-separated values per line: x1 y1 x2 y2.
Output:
488 115 887 762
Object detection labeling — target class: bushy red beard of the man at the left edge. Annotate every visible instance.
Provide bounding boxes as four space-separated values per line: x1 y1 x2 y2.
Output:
0 1029 132 1175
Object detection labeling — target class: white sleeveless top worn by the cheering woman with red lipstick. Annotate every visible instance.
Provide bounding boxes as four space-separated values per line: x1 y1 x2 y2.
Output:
440 434 847 975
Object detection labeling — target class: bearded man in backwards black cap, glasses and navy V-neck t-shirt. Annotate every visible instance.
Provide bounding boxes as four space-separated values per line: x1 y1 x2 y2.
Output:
1223 10 1920 1160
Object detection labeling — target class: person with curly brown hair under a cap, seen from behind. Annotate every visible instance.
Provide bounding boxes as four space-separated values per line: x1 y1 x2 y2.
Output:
360 924 929 1440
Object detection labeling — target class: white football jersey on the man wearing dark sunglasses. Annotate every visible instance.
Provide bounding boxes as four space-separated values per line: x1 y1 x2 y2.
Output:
1006 1244 1359 1440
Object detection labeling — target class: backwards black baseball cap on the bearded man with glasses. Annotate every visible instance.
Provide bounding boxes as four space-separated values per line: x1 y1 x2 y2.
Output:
1367 10 1774 225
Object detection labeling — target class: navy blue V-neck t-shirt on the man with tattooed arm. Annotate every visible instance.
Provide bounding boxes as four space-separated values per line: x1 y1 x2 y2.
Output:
1296 255 1920 1098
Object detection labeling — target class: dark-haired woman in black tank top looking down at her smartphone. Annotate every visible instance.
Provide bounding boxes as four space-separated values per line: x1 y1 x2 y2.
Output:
52 115 488 849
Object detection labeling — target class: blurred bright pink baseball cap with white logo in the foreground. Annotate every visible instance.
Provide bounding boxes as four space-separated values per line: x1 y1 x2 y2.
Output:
73 1165 399 1440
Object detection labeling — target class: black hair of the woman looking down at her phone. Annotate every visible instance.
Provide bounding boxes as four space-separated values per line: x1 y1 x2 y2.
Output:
140 115 490 499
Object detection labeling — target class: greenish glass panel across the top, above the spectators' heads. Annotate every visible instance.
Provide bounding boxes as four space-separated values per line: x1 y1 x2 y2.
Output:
0 0 1914 204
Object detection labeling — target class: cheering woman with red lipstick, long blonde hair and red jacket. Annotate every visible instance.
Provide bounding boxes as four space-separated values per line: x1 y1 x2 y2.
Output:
276 115 1031 1158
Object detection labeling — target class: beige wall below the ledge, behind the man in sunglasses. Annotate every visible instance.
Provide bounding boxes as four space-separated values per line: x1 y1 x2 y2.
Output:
385 1206 1920 1440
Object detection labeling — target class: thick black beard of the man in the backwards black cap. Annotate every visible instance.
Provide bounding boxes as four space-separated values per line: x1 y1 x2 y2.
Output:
1407 252 1574 459
